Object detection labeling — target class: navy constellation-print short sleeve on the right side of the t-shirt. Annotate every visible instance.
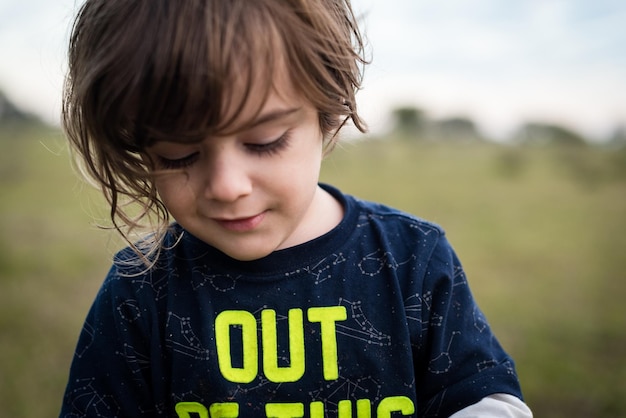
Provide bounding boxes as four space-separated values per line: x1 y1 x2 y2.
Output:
415 235 522 417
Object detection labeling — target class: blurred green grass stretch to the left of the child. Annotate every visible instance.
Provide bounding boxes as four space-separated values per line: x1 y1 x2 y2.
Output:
0 124 110 417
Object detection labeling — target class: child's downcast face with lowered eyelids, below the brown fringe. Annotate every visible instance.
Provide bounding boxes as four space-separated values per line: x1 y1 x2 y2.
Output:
147 77 342 260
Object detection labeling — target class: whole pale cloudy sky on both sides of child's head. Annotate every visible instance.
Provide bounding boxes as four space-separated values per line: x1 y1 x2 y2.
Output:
0 0 626 140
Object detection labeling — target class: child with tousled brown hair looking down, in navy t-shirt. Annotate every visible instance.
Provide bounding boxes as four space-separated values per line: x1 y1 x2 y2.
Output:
61 0 531 418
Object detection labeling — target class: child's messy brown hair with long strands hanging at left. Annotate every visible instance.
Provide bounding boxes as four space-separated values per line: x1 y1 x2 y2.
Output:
62 0 366 260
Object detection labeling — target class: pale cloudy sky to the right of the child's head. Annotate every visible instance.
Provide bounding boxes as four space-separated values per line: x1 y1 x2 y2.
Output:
356 0 626 137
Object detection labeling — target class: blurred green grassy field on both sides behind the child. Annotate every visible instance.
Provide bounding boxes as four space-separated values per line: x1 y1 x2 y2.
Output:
0 128 626 418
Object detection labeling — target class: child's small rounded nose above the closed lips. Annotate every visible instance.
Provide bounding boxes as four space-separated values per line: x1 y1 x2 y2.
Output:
204 153 252 202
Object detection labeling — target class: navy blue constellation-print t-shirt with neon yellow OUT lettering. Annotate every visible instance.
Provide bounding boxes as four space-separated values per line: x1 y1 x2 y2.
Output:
61 186 521 418
